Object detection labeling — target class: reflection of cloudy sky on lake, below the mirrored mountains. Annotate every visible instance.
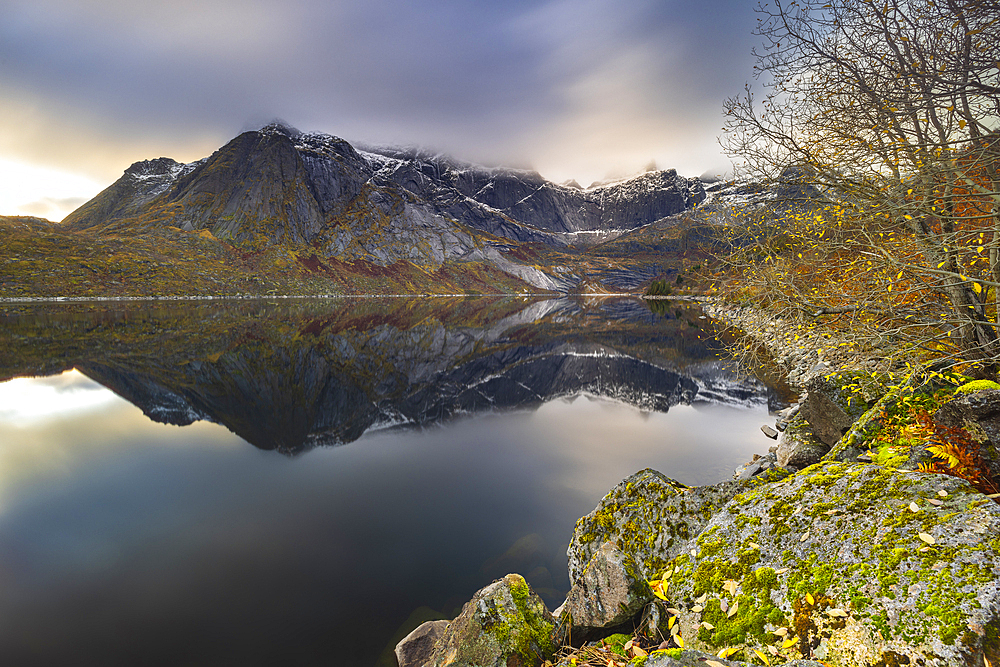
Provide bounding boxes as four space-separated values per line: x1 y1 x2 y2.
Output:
0 376 768 666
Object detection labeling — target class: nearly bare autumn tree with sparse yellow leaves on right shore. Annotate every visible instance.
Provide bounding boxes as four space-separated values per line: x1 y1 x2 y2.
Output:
722 0 1000 366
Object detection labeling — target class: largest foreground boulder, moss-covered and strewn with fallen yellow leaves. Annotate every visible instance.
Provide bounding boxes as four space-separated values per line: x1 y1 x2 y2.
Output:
572 461 1000 665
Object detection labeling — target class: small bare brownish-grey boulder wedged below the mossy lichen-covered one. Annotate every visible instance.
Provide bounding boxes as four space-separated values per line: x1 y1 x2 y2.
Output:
558 542 653 641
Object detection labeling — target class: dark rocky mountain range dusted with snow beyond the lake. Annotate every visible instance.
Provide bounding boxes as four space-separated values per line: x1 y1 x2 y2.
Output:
64 123 705 291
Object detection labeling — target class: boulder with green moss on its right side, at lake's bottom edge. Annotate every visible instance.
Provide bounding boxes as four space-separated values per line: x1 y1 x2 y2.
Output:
426 574 557 667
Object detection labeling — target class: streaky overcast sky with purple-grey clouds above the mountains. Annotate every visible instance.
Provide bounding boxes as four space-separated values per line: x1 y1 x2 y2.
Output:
0 0 756 220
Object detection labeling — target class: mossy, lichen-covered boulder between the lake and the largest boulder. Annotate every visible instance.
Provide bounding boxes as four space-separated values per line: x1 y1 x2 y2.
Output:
567 468 788 584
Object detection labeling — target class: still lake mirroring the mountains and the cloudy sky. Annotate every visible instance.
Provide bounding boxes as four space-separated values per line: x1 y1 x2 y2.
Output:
0 297 778 667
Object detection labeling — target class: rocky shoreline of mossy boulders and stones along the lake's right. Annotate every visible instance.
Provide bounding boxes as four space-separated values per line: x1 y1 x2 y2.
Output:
396 303 1000 667
